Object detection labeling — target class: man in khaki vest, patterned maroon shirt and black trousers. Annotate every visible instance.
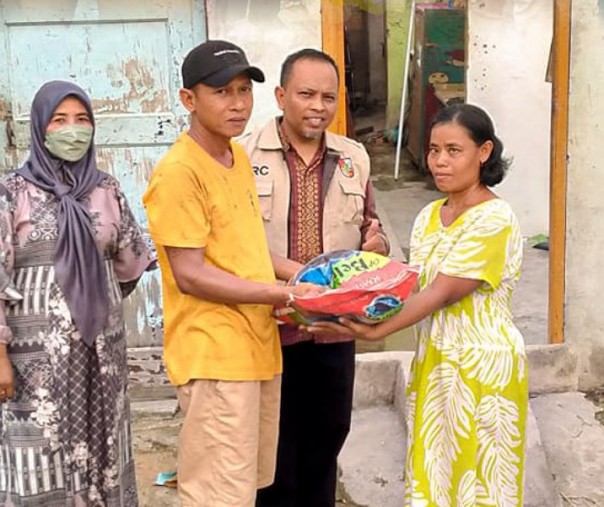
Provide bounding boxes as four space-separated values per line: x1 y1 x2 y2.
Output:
242 49 389 507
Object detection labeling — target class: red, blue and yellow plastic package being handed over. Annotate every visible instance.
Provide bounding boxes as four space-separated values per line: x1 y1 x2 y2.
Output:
275 250 419 324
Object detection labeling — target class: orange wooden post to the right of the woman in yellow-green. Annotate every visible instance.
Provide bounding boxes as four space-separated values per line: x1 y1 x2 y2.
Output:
548 0 571 343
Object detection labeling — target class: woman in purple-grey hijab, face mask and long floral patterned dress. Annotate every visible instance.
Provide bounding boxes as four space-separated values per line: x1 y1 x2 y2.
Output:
0 81 154 507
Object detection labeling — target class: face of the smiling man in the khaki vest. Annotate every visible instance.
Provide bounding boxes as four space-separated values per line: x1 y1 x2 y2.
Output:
275 59 338 140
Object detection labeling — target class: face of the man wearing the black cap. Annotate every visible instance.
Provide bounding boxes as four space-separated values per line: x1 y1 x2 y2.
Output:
180 74 254 140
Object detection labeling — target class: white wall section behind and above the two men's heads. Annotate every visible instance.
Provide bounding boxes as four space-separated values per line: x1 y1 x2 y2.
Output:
206 0 322 131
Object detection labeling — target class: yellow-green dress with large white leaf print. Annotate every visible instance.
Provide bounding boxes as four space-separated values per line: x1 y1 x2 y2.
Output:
405 199 528 507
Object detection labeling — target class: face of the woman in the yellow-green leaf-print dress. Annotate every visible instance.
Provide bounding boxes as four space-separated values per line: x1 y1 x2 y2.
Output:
428 123 493 193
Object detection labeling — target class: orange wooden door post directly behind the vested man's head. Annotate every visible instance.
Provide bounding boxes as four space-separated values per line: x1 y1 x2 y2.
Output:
321 0 346 136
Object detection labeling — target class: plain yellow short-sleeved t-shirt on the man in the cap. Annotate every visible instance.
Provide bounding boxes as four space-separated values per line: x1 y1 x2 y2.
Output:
143 132 281 385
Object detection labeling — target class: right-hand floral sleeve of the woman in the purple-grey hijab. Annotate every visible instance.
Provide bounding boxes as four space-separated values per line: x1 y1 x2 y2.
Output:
113 188 157 297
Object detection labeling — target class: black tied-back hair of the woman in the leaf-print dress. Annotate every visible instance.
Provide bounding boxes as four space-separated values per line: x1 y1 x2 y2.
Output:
430 104 511 187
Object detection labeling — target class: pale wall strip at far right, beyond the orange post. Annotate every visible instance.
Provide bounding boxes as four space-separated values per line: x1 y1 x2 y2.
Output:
565 0 604 387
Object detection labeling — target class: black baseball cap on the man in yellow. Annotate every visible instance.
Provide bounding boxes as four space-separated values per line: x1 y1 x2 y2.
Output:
181 40 264 89
